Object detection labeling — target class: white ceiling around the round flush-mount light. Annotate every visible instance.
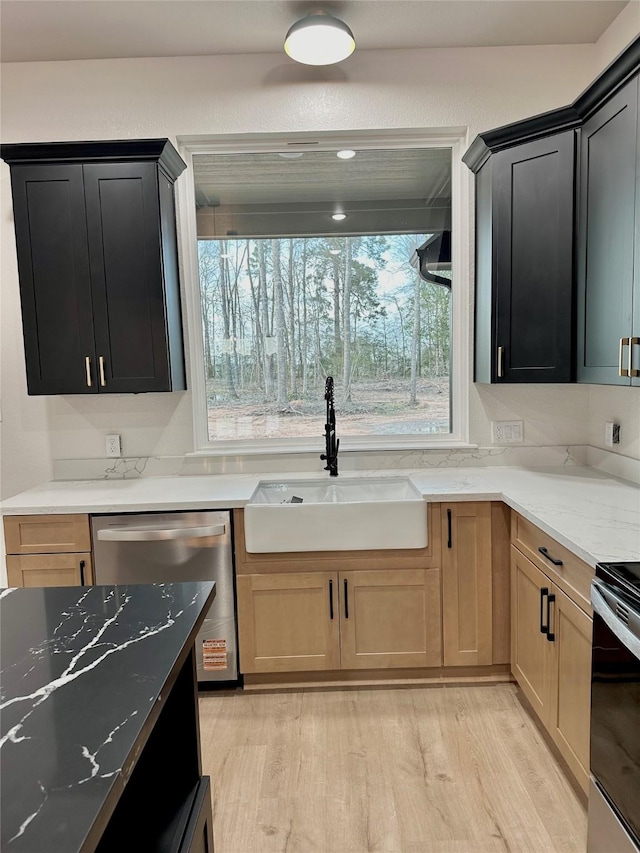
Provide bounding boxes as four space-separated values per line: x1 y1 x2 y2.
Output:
0 0 627 62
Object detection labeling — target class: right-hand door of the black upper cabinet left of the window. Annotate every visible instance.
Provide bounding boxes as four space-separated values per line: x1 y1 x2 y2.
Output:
84 163 176 393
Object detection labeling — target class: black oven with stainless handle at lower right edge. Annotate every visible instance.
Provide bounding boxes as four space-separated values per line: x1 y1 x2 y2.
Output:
587 563 640 853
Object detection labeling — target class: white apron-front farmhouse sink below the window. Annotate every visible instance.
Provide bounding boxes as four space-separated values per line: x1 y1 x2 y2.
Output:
244 477 427 553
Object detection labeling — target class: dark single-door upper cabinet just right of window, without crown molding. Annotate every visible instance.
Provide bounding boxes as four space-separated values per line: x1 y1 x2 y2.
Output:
475 131 575 383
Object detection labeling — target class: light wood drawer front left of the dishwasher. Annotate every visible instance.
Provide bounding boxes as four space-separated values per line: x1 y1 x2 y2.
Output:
4 515 91 554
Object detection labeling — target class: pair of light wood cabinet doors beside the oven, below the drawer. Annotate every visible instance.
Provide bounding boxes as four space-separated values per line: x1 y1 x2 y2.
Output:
511 547 593 793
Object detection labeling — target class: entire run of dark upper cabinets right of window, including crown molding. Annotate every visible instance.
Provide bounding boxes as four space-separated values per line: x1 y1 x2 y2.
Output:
462 38 640 384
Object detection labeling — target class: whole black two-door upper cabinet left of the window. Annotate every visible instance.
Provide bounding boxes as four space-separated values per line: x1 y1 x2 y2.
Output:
0 140 186 394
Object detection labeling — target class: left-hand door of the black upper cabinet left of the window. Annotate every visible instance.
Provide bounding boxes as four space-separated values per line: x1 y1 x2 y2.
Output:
11 164 98 394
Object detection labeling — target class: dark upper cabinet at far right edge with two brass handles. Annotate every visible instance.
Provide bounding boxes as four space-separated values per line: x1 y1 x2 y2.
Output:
577 76 640 385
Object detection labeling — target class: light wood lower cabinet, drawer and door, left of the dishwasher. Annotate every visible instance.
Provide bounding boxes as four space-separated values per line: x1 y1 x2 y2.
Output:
4 514 93 587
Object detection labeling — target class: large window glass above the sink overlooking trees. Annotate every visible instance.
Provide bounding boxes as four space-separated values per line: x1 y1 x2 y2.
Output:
182 135 468 452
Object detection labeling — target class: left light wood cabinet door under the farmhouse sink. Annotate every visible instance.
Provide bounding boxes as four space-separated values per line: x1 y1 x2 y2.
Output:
237 572 340 673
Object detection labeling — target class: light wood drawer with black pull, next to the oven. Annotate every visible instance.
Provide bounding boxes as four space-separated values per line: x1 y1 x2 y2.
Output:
511 512 595 616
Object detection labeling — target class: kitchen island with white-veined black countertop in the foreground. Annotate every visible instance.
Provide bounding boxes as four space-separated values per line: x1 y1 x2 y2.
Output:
0 582 215 853
